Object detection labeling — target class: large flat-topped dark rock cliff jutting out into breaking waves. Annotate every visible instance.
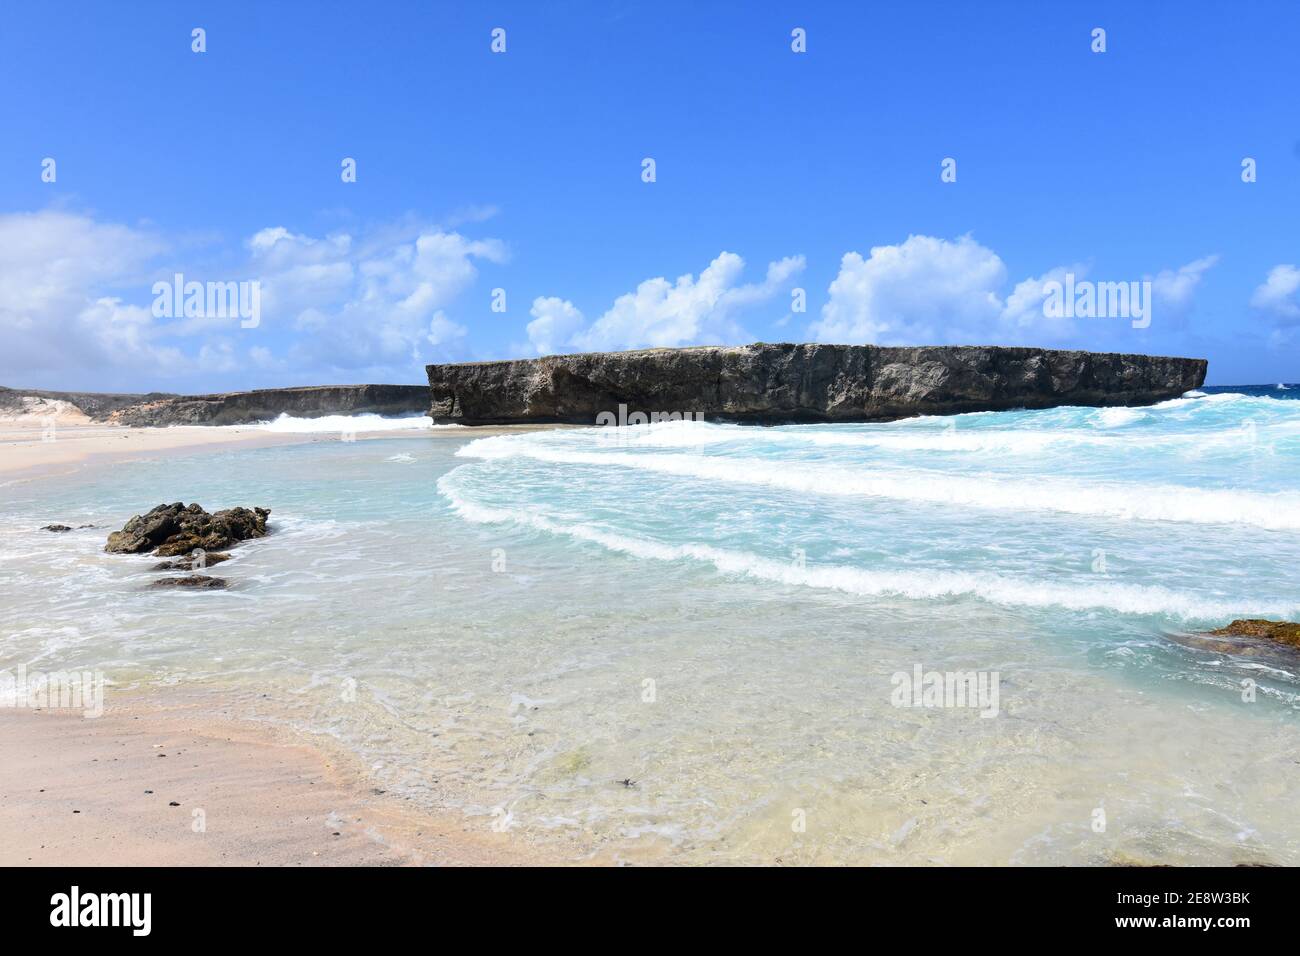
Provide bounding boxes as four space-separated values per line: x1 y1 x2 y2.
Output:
428 343 1206 424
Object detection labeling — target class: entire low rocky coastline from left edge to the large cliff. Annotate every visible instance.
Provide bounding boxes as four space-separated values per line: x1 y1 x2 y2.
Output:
0 385 429 427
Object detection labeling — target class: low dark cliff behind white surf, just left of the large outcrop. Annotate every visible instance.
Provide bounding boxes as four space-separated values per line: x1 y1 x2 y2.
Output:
108 385 429 427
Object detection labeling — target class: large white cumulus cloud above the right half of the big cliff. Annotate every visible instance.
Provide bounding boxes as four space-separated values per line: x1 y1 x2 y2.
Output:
809 235 1217 345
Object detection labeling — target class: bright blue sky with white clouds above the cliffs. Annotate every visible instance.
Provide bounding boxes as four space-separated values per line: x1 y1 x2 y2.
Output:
0 0 1300 392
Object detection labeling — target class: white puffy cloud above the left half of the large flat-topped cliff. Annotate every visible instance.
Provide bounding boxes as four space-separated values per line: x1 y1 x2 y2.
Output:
569 252 803 351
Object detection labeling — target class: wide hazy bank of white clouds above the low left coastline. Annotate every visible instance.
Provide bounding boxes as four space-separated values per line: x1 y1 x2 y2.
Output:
0 211 507 388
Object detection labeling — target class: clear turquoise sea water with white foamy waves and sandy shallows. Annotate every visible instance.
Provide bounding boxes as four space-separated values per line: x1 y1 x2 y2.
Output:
0 389 1300 864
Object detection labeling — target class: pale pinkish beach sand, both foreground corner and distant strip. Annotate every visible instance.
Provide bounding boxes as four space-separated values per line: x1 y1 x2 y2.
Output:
0 416 566 866
